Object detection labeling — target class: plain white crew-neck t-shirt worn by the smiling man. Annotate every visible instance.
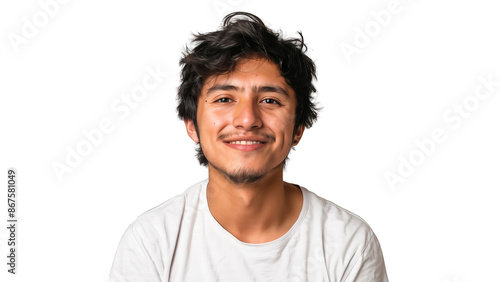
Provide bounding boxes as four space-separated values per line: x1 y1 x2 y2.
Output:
110 180 387 282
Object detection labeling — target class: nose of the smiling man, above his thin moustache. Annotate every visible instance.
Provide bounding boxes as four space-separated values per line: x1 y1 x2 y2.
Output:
233 100 262 130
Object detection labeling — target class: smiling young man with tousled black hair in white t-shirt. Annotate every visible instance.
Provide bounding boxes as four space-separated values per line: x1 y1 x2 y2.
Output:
111 12 387 282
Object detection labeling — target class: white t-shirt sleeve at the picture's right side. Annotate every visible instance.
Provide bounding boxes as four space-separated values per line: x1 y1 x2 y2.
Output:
341 233 388 282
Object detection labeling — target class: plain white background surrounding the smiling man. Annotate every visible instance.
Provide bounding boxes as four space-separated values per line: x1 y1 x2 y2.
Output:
0 0 500 282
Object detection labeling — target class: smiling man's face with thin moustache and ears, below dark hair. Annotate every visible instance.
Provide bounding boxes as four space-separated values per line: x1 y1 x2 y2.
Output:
185 58 304 183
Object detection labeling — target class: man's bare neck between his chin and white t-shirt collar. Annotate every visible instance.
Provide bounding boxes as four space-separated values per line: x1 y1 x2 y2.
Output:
207 165 302 243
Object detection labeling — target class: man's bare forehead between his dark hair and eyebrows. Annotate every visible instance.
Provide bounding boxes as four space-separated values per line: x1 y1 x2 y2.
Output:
201 58 295 96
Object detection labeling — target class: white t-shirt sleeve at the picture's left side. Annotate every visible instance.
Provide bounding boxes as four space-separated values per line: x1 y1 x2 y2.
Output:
110 225 161 282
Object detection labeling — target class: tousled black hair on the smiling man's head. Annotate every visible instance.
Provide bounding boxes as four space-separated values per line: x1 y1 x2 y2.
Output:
177 12 318 166
